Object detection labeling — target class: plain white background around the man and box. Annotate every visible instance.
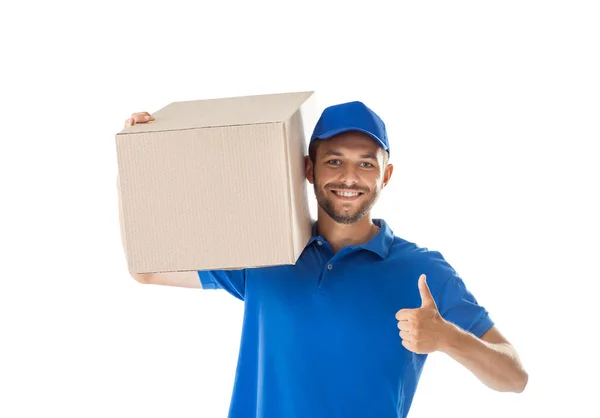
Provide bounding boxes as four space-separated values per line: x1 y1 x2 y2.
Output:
0 0 600 418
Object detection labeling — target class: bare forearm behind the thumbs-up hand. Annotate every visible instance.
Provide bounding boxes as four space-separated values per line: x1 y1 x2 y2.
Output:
441 323 528 392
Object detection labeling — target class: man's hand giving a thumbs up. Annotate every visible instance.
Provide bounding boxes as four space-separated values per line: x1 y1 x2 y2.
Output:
396 274 451 354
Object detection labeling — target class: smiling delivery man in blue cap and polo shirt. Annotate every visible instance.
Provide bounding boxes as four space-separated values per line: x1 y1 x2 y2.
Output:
120 102 528 418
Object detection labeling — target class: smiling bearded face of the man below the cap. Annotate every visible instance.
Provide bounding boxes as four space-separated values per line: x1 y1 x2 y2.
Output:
306 131 393 224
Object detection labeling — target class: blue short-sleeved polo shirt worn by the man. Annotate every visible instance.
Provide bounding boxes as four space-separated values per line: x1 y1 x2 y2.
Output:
198 219 493 418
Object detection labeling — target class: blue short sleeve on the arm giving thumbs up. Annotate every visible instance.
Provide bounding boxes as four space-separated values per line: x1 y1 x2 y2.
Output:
428 251 494 337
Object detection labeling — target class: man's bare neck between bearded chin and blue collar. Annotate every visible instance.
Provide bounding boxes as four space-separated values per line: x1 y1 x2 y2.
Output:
317 208 379 253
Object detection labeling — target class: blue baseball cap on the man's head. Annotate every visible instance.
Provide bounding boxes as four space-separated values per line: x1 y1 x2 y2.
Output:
309 102 390 154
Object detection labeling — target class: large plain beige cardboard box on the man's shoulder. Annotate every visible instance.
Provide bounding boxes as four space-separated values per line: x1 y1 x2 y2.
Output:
116 92 318 273
